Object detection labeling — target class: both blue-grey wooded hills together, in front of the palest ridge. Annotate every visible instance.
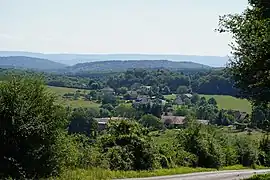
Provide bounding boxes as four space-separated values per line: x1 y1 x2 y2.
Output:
0 56 225 73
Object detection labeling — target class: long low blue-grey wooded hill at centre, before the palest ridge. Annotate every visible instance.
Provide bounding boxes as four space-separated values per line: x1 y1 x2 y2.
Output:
67 60 211 72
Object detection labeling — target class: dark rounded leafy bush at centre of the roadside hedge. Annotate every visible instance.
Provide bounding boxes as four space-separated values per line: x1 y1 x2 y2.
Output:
100 120 159 170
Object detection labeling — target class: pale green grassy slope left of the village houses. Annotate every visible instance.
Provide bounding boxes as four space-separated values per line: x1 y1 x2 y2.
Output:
49 86 100 108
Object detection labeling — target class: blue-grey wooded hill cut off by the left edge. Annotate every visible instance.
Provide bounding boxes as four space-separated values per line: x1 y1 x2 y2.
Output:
0 56 66 70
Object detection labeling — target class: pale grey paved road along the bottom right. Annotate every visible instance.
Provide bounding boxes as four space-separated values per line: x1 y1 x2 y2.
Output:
116 169 270 180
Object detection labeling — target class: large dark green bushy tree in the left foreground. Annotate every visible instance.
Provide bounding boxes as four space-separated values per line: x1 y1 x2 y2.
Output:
0 76 76 179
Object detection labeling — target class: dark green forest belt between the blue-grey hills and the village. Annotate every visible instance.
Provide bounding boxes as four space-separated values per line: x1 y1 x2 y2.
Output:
0 69 236 96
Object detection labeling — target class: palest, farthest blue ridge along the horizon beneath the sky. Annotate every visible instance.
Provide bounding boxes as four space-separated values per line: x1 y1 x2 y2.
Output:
0 51 228 67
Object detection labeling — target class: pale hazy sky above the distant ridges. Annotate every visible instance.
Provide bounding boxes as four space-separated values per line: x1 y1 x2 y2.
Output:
0 0 247 56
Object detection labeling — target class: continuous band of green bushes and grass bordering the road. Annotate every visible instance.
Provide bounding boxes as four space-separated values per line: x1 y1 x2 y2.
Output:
0 76 270 179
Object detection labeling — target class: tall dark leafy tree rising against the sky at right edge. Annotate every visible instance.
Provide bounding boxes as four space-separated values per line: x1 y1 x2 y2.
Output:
218 0 270 104
